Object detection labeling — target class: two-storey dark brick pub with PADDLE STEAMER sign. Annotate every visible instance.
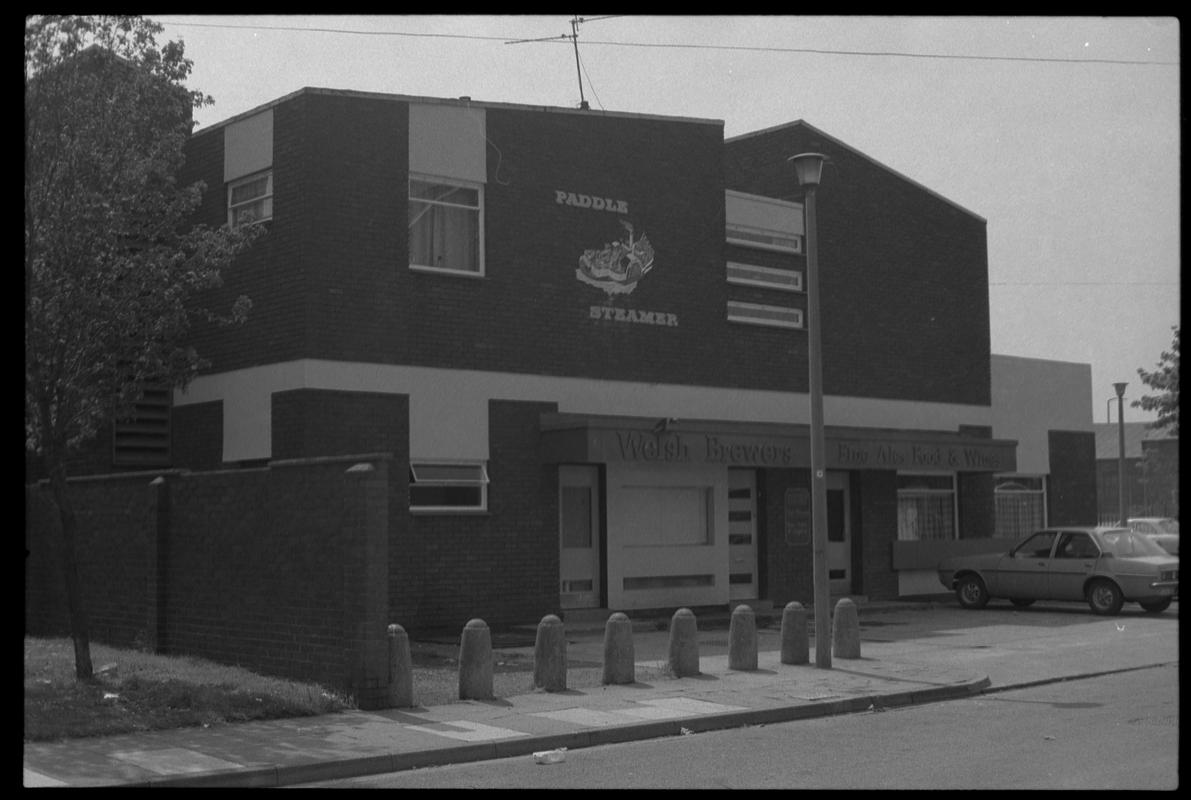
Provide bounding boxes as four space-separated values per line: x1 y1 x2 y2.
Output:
92 88 1096 627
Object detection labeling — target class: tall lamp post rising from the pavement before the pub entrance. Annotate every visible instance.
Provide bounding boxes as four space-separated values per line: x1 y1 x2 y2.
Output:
787 152 831 669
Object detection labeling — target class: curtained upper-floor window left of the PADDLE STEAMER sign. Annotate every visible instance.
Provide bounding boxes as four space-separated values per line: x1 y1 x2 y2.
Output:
410 176 484 275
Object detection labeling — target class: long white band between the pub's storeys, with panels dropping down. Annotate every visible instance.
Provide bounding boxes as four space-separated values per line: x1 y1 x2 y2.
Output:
174 360 1000 471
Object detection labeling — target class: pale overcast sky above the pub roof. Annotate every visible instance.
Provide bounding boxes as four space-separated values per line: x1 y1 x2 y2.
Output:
154 14 1180 423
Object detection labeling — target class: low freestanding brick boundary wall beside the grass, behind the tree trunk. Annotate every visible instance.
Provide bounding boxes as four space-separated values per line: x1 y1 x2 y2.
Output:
25 458 391 702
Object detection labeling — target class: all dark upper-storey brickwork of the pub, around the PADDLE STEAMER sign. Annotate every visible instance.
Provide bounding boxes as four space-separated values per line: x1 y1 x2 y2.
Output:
183 93 948 392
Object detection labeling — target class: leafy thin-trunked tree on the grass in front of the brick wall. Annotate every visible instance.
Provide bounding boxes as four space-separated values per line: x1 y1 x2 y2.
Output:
25 17 260 680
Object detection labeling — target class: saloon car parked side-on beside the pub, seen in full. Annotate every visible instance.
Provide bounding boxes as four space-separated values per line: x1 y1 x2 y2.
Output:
939 527 1179 615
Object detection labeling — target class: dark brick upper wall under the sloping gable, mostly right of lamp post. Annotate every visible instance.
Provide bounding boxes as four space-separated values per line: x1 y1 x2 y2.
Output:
724 125 991 405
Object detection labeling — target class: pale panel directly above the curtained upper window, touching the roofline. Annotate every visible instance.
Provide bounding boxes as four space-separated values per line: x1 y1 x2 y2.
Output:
410 102 488 183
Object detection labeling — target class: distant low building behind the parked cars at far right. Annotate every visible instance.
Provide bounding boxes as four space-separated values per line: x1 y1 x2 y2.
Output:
1095 421 1179 524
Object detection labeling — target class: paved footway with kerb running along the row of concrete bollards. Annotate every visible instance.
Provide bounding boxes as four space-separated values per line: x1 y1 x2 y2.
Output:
24 600 1171 787
